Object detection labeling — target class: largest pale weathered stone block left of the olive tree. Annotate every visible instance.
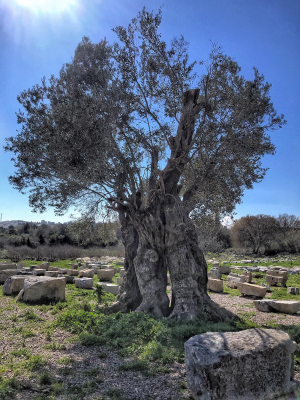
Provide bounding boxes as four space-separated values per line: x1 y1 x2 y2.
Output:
17 276 66 303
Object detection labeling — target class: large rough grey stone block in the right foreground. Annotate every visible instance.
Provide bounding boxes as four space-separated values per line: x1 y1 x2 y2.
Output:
184 329 296 400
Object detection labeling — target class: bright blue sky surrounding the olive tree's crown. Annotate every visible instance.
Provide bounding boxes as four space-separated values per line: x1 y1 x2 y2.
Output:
0 0 300 222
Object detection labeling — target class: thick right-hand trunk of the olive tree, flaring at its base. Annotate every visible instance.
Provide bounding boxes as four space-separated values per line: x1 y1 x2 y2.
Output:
165 196 234 322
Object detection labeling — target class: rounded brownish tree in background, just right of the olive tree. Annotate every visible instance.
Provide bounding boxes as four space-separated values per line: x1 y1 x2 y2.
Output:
231 214 279 254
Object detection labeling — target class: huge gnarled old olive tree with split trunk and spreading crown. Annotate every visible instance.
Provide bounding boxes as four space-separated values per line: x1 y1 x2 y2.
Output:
6 9 284 320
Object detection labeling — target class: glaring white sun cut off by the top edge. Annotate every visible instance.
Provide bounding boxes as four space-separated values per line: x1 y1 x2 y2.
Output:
15 0 78 14
